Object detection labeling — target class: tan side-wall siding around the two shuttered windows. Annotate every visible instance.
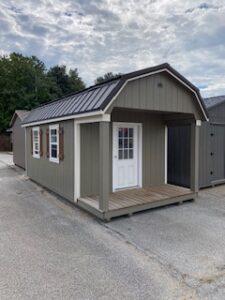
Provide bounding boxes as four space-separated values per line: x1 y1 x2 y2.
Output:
27 121 74 201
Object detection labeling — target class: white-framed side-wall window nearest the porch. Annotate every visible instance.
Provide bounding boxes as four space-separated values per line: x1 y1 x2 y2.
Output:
49 125 59 163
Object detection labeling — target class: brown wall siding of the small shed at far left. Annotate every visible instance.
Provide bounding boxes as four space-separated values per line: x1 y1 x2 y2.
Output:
13 117 25 169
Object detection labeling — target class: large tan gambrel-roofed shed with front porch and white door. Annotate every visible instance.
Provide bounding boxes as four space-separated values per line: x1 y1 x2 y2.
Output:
23 63 207 220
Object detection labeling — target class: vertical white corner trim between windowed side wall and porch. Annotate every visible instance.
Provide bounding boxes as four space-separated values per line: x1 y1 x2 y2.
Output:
74 120 80 202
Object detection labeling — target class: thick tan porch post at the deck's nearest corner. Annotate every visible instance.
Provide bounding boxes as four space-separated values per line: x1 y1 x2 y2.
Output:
99 122 110 212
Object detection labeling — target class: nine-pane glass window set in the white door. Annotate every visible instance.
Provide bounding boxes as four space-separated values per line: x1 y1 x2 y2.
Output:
118 127 134 159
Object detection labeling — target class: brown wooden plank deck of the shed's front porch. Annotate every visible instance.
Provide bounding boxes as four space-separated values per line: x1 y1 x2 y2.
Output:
78 184 195 219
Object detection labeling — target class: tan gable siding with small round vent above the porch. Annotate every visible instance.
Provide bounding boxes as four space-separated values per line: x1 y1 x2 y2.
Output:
108 73 202 119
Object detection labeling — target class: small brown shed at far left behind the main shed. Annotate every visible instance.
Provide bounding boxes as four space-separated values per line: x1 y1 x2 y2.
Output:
10 110 29 169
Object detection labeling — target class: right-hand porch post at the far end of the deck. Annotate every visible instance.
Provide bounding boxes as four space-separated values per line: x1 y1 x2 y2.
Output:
191 120 201 193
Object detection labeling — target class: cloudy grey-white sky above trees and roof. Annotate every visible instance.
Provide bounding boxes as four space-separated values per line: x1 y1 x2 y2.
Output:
0 0 225 96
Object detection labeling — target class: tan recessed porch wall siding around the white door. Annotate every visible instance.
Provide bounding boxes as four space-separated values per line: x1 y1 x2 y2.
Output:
81 111 165 197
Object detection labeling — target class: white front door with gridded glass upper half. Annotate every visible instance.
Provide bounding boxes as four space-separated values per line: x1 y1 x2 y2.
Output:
113 123 139 190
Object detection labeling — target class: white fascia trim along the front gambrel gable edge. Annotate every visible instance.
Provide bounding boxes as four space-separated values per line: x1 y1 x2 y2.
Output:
104 68 209 121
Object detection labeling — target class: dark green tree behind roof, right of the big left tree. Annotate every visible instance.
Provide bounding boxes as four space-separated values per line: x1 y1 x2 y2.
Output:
47 65 85 97
